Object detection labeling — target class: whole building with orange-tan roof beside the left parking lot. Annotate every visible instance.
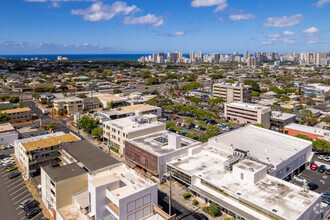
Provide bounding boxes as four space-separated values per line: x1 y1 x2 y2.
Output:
14 132 80 177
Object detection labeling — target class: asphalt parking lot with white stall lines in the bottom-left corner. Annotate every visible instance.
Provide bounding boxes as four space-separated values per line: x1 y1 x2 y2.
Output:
0 149 43 220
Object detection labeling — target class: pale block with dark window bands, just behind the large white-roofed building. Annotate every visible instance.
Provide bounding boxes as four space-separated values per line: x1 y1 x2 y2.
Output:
224 102 271 128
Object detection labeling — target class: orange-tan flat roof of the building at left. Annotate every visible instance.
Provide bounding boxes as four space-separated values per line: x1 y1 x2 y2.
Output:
22 133 80 151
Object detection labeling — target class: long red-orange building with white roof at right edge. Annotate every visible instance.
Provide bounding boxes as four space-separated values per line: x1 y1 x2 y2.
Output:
284 123 330 141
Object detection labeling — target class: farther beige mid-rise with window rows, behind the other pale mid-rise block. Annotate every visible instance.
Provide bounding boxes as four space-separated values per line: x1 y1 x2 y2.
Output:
213 82 252 102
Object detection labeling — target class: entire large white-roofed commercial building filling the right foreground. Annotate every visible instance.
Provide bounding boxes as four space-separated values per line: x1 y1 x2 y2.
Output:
167 126 321 220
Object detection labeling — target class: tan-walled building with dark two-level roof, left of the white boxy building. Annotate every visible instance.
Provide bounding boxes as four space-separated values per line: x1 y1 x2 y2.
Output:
41 140 119 219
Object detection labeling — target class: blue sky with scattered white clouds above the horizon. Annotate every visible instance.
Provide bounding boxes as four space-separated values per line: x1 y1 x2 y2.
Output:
0 0 330 55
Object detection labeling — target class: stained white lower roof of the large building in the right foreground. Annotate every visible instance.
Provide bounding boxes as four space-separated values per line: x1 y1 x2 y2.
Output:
168 145 320 219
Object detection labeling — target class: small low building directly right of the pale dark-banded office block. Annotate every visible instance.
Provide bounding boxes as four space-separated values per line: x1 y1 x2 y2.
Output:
270 111 296 132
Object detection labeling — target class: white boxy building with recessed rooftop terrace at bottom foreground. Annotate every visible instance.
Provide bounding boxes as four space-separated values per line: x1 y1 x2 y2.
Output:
88 164 158 220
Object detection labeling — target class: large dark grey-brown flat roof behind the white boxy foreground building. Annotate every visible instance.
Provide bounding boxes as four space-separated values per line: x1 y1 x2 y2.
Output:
61 140 119 171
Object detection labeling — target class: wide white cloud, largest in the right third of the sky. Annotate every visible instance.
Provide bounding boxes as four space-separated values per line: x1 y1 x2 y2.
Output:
264 14 304 27
